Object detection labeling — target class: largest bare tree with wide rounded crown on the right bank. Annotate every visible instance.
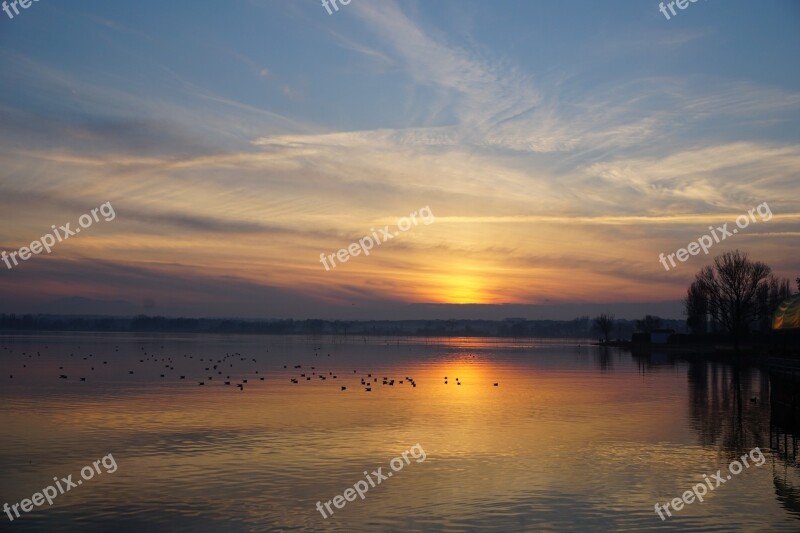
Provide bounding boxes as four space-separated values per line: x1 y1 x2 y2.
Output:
695 250 771 351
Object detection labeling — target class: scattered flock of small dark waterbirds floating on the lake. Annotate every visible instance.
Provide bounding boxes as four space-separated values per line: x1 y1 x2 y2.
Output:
0 340 500 392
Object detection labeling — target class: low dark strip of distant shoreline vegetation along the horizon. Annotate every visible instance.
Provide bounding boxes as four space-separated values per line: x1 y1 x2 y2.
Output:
0 314 686 339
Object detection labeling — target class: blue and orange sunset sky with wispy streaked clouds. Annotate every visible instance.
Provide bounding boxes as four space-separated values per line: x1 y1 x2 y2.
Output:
0 0 800 319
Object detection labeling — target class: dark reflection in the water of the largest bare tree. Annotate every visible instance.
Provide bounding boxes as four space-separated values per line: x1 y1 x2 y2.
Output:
687 360 769 461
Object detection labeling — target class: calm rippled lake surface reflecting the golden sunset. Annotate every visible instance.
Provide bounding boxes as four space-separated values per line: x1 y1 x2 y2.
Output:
0 334 800 531
